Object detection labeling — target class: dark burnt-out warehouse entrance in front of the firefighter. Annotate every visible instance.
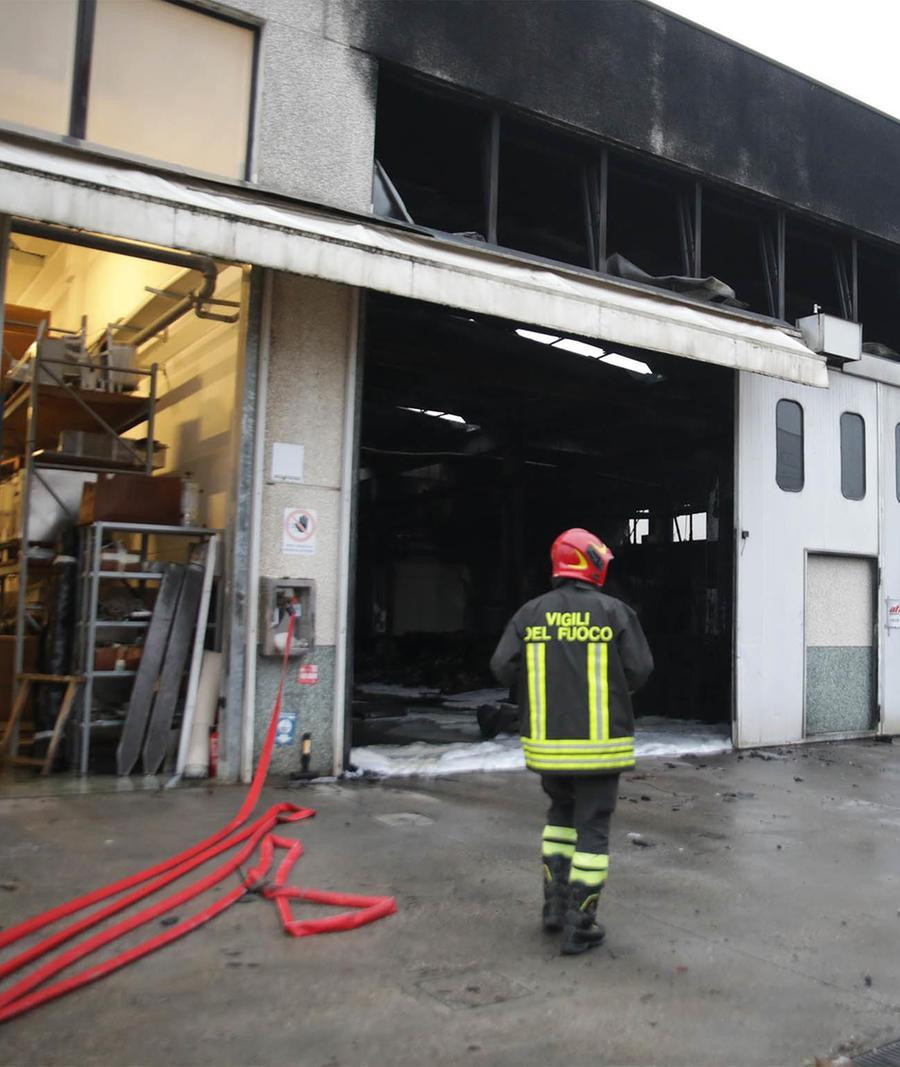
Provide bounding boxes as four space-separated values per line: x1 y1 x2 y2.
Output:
352 294 735 776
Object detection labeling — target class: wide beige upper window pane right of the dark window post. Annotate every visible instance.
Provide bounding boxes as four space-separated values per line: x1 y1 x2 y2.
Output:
88 0 255 178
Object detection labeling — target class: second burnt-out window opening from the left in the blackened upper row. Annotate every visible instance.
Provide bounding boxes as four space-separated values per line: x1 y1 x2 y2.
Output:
498 122 590 267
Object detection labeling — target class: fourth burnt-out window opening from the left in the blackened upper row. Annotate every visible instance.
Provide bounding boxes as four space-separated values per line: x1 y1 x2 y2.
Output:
701 188 778 316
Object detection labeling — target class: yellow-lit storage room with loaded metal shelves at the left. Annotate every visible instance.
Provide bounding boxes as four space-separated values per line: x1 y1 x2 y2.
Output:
0 221 244 777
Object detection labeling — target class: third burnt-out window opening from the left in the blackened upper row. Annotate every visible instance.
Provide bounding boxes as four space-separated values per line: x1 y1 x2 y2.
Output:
606 159 691 277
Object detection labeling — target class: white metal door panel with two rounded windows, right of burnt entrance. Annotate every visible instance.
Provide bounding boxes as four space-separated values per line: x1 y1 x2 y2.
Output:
736 371 879 747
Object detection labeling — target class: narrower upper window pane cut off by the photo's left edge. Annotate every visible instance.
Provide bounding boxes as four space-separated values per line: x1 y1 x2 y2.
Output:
0 0 78 133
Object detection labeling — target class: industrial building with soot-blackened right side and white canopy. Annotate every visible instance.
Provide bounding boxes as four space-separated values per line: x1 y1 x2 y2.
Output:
0 0 900 780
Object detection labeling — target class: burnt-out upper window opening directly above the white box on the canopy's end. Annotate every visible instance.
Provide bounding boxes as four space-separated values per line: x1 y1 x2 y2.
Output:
785 219 852 322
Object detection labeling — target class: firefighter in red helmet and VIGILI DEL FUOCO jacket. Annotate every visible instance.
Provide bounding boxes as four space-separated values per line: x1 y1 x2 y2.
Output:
491 529 653 956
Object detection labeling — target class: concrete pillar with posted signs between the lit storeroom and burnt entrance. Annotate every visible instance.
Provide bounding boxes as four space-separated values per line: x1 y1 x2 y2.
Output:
254 274 358 774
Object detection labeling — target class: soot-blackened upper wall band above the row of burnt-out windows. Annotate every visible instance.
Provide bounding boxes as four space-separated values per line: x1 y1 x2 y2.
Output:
339 0 900 241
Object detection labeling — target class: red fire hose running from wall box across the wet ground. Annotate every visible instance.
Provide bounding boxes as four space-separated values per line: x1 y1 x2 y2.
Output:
0 616 397 1022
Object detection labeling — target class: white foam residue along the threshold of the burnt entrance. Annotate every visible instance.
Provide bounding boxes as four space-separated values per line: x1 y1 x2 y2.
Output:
350 717 731 778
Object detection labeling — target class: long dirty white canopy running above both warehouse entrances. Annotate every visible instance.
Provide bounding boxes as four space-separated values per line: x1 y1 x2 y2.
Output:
0 138 827 386
